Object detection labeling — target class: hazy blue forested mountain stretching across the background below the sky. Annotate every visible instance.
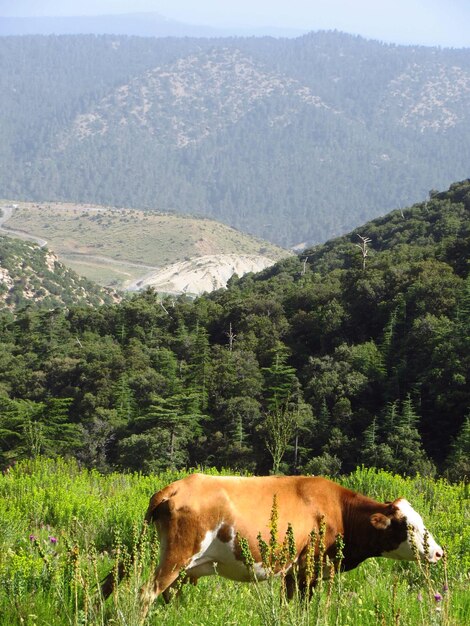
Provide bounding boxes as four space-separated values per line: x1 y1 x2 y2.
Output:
0 32 470 246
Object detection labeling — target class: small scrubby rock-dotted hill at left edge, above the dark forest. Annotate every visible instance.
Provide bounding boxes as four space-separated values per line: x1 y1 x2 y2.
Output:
0 235 120 311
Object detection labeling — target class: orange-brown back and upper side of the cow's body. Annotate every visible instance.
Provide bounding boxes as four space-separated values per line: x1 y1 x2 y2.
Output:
147 474 343 549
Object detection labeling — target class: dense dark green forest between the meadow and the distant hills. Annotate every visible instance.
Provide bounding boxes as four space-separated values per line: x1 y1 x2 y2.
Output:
0 180 470 478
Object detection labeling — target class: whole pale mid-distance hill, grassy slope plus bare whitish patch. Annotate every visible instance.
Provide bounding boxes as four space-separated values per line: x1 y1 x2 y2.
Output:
0 202 290 294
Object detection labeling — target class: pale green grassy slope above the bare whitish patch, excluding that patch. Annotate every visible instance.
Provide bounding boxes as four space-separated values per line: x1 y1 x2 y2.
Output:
6 203 288 286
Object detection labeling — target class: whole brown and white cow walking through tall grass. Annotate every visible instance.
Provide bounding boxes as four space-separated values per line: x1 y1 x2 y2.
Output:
103 474 443 617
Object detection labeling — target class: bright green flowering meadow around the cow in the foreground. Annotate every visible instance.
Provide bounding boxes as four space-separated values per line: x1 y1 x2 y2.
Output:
0 459 470 626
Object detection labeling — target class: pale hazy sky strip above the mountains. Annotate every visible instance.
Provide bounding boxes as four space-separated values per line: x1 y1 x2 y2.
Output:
0 0 470 47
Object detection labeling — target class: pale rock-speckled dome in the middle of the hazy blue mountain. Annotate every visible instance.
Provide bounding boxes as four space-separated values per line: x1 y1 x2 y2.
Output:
63 48 330 150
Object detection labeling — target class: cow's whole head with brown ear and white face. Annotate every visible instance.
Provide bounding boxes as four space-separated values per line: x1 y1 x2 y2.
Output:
371 498 443 563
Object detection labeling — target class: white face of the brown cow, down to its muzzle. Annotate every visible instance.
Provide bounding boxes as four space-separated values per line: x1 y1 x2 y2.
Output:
383 499 443 563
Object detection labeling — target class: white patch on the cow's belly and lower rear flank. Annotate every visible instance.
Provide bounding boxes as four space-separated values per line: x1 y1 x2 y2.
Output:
186 524 266 582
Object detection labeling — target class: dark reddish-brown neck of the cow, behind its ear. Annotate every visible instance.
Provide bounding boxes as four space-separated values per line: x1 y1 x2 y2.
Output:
342 494 387 571
